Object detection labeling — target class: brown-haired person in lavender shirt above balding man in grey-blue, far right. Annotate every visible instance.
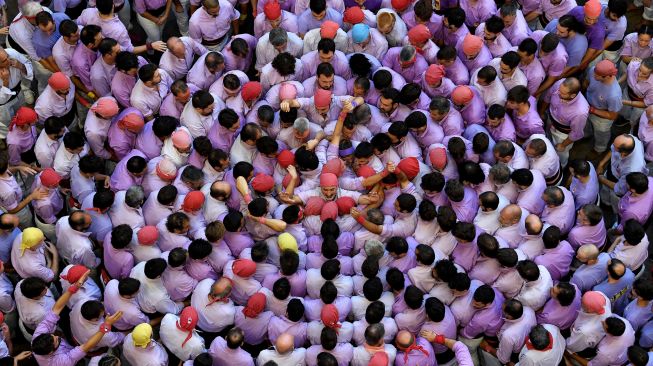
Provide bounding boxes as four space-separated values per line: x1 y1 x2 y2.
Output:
567 204 606 250
